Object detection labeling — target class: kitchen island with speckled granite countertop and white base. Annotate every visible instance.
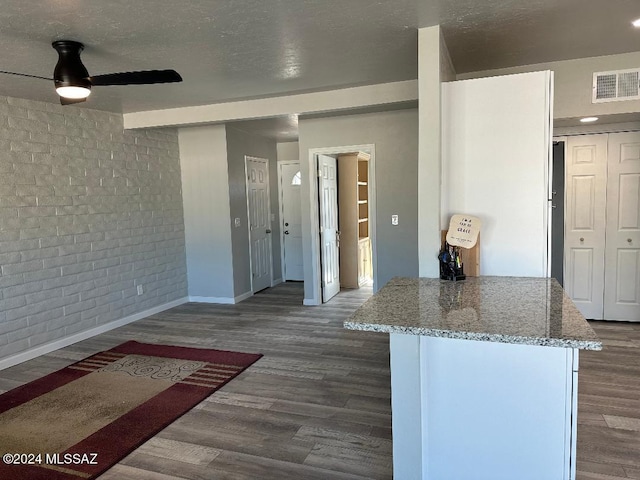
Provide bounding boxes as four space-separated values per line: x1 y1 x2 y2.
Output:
344 277 602 480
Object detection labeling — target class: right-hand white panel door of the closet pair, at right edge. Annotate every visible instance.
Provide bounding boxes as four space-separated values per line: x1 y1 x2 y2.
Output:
604 132 640 321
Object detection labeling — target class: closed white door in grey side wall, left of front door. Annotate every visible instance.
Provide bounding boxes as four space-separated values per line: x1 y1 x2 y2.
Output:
245 157 272 293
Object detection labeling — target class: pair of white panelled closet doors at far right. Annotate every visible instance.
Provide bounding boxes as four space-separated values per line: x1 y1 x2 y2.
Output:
564 132 640 322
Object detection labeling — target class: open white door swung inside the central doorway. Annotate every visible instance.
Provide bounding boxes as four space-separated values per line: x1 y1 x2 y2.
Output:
318 155 340 302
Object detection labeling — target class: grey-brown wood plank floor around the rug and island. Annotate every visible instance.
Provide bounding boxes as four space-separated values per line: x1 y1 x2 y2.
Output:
0 283 640 480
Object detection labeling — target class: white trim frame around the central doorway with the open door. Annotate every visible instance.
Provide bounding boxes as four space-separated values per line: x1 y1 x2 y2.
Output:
303 143 378 305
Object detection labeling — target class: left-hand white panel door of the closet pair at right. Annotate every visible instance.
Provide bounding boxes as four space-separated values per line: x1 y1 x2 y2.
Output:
564 134 607 319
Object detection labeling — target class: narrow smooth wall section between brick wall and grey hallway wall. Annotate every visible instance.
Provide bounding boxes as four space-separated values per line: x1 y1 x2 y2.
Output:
178 125 234 303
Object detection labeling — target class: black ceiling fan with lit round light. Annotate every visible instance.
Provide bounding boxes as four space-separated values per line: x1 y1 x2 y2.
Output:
0 40 182 105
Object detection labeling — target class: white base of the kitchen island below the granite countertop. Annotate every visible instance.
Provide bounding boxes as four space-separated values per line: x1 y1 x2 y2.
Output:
390 333 578 480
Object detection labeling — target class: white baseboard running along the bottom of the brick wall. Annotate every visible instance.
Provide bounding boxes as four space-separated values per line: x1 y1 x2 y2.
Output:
0 297 189 370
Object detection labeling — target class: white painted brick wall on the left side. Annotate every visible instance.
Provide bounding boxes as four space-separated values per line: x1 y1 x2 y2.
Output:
0 97 187 359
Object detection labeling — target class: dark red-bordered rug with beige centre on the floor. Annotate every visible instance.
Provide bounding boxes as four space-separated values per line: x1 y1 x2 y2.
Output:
0 341 262 480
